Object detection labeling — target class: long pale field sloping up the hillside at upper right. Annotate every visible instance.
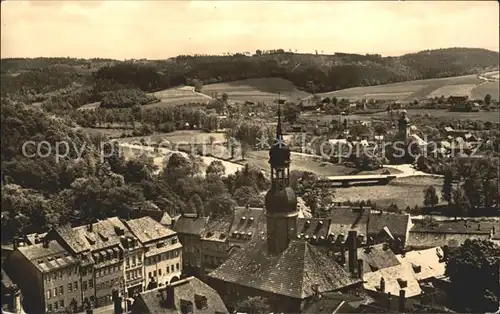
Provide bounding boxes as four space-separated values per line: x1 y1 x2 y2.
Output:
318 75 484 101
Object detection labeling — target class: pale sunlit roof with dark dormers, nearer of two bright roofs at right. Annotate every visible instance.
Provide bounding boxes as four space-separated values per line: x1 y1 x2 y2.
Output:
363 263 422 298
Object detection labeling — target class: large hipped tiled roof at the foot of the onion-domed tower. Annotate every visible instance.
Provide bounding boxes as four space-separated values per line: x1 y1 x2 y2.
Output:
209 238 360 299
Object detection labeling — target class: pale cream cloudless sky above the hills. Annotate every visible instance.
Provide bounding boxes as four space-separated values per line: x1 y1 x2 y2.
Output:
1 0 500 59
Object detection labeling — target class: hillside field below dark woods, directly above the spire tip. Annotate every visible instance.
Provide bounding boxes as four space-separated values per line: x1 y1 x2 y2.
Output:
202 77 309 102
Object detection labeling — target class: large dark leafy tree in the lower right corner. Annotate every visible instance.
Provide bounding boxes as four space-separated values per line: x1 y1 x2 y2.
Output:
446 239 500 313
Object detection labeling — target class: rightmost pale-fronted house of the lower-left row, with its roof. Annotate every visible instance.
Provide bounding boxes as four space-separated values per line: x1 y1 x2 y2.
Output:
125 216 182 295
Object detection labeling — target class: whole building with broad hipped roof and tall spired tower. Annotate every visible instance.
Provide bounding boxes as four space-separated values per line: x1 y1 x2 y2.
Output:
208 107 361 313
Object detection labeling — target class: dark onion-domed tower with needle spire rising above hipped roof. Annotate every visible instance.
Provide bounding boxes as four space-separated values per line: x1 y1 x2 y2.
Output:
265 105 298 254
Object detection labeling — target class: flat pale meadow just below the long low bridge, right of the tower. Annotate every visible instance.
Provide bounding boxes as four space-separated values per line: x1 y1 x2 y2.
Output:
335 176 443 209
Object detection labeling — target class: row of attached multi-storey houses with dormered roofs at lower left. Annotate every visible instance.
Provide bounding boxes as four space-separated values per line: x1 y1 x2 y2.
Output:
3 217 182 313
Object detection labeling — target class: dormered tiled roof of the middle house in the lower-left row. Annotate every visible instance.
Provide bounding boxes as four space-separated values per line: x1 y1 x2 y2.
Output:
56 217 132 253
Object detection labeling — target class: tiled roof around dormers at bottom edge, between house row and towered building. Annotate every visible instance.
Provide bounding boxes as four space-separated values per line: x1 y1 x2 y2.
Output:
134 277 229 314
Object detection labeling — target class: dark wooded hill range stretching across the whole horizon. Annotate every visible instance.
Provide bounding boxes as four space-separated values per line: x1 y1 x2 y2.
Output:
1 48 499 102
